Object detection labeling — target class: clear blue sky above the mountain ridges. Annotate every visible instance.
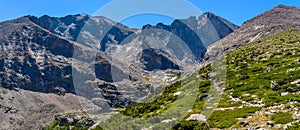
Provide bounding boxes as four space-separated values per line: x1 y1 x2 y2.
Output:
0 0 300 27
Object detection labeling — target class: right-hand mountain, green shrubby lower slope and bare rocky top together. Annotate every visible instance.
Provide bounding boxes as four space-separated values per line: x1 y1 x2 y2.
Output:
94 5 300 130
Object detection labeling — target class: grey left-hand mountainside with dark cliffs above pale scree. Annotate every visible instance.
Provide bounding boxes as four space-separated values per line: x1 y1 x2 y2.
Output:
0 17 134 129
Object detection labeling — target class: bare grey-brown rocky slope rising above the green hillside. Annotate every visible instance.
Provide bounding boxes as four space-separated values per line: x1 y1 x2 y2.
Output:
205 5 300 61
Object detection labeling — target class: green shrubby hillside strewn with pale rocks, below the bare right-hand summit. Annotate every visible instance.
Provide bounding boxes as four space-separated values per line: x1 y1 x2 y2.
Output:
94 30 300 129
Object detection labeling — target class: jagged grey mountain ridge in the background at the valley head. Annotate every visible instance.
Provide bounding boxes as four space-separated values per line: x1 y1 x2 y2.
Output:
31 12 237 70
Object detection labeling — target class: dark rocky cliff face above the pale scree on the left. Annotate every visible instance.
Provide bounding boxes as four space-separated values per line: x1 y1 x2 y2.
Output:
0 17 135 93
